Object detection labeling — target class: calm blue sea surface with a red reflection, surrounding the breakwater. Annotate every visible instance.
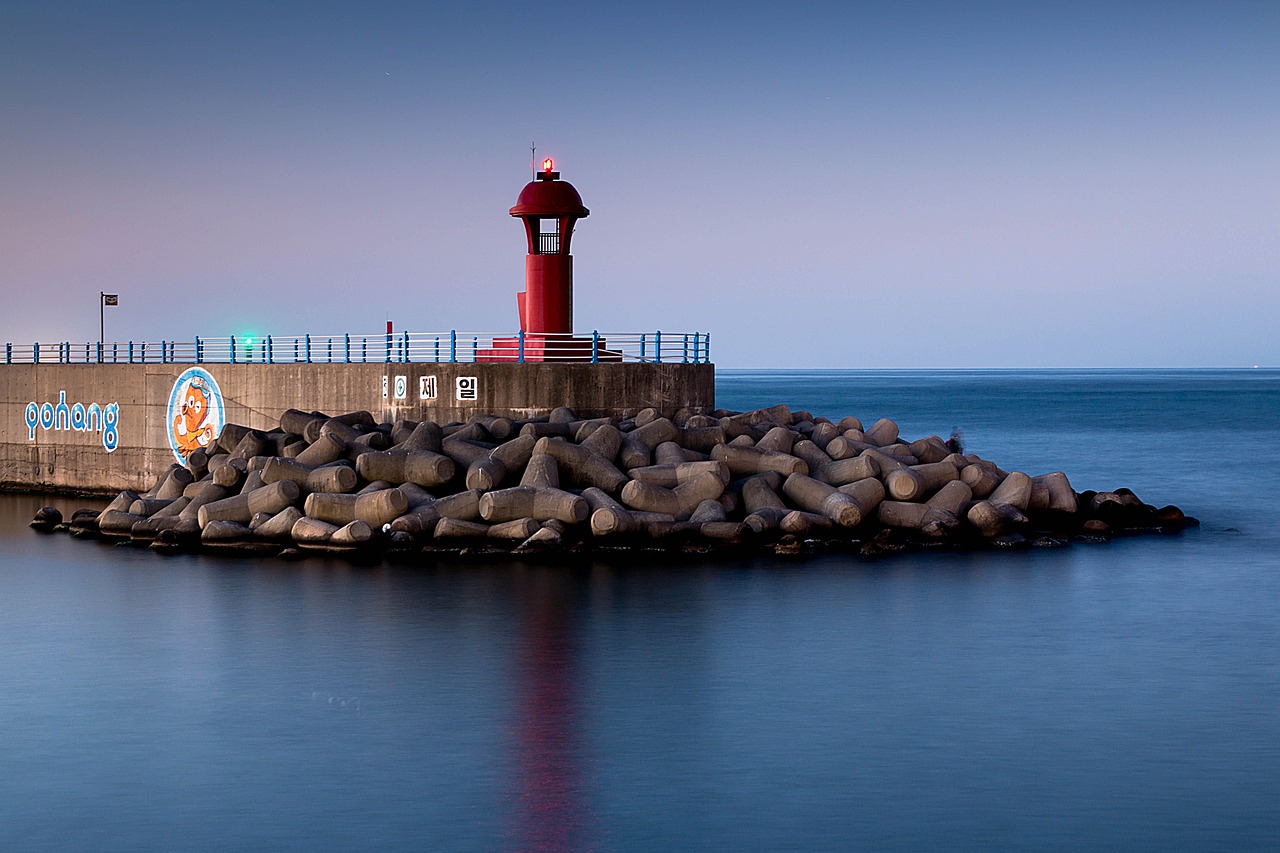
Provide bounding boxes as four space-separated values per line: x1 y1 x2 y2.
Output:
0 370 1280 850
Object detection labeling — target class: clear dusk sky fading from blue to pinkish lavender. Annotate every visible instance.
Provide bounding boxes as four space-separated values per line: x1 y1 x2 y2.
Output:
0 0 1280 368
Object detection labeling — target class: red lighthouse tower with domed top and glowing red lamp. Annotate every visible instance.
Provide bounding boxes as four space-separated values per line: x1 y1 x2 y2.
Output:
511 158 591 334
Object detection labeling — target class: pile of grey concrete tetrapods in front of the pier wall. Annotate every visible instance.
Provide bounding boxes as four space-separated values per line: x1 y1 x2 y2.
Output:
31 405 1197 562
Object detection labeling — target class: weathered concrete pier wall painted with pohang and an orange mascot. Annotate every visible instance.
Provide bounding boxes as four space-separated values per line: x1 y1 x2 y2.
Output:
0 362 716 492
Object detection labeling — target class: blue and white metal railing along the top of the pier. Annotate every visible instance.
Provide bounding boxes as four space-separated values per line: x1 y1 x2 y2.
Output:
4 329 712 364
